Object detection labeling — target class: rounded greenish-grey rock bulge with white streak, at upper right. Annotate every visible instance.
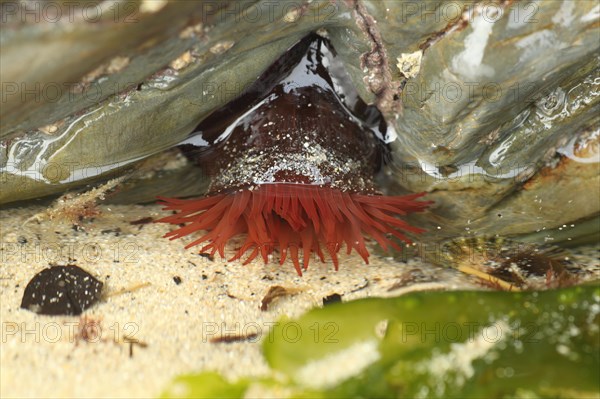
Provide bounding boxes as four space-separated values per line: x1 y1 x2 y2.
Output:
396 0 599 170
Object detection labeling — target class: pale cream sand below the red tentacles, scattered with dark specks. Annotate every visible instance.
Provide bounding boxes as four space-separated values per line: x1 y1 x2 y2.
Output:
0 205 596 398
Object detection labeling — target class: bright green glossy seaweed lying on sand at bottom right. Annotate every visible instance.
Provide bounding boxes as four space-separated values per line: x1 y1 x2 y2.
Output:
161 285 600 398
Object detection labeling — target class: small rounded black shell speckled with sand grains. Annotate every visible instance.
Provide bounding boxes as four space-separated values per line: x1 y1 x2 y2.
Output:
21 265 104 316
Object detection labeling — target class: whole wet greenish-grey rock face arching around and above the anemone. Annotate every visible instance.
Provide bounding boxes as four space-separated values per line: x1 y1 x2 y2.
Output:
0 0 600 242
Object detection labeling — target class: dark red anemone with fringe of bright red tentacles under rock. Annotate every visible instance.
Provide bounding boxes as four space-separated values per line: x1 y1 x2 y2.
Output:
158 35 430 275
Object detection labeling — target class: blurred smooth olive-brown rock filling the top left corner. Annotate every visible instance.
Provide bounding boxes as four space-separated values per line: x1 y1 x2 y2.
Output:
0 1 214 139
